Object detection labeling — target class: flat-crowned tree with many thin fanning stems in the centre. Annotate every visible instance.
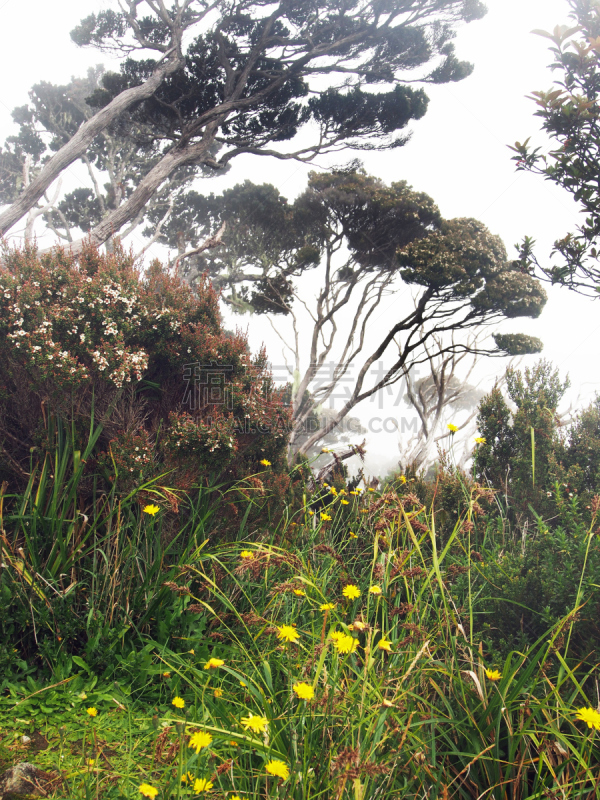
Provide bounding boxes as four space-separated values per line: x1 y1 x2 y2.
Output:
170 168 545 453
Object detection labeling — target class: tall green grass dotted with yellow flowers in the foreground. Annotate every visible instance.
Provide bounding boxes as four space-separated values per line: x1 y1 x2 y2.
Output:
0 476 600 800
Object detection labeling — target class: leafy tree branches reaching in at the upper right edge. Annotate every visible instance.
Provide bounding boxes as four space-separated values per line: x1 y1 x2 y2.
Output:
512 0 600 297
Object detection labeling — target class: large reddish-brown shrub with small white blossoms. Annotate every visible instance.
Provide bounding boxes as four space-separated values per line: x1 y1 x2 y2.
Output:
0 246 288 490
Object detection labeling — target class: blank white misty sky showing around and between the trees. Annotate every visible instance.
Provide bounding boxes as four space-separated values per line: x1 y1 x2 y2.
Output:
0 0 600 474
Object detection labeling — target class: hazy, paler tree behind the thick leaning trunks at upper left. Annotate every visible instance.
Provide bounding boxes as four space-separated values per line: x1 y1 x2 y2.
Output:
0 66 209 250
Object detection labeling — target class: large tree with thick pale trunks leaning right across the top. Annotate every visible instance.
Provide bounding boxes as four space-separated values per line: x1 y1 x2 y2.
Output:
0 0 485 252
